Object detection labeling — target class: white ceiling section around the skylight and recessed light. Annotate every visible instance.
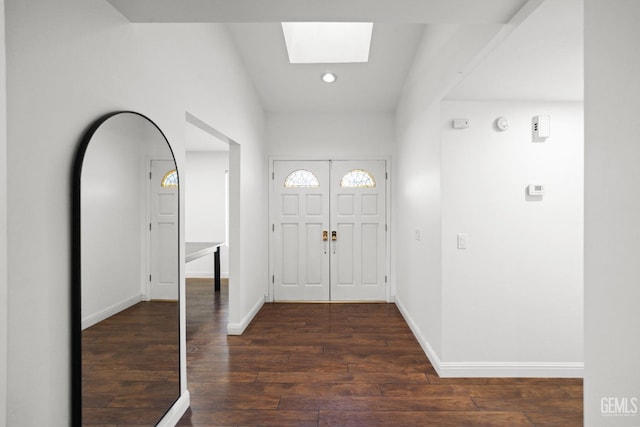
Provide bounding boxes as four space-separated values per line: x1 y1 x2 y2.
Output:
229 23 423 112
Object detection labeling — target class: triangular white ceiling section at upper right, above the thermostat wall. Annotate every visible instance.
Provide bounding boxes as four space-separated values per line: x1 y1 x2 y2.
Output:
447 0 584 101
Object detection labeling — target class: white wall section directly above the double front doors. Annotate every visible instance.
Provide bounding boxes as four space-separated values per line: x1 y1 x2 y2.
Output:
267 112 395 159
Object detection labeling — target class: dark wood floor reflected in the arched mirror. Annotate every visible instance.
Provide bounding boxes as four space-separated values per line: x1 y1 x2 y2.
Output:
82 302 180 427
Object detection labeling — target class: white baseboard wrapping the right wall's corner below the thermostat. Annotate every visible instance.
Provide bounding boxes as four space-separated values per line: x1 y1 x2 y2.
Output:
396 296 584 378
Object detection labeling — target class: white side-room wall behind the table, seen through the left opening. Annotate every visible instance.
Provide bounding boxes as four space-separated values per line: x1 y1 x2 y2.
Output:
184 151 229 277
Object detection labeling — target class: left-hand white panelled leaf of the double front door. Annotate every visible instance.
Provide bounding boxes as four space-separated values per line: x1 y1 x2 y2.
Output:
272 161 329 301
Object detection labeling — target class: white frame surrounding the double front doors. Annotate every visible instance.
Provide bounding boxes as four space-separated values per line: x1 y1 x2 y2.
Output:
266 156 395 302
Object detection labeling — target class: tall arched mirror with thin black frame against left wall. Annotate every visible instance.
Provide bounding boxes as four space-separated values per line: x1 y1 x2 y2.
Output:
72 111 180 426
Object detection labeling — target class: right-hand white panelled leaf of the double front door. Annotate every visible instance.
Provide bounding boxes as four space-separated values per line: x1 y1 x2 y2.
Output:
331 161 386 301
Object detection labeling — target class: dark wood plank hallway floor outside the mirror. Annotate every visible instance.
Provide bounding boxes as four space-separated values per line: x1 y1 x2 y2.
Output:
178 279 583 427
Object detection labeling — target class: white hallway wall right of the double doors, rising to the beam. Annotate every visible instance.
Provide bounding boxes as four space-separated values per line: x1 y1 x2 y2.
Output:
392 25 508 372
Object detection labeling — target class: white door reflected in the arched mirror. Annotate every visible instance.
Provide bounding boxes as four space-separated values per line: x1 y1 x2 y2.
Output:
150 160 179 300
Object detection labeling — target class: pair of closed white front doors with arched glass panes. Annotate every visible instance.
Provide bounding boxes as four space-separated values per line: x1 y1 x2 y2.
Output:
271 160 387 301
